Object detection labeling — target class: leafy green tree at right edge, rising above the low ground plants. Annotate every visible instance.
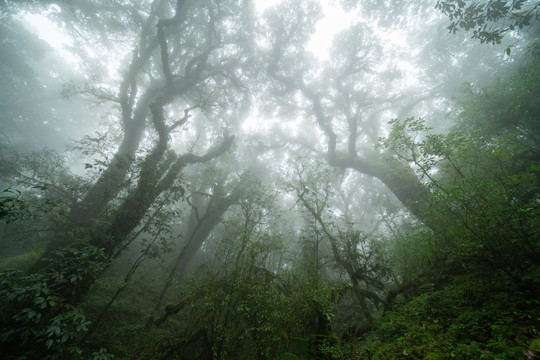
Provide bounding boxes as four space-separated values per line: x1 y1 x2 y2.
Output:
383 64 539 292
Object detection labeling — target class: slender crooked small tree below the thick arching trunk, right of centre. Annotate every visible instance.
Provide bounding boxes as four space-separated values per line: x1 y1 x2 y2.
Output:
289 162 396 332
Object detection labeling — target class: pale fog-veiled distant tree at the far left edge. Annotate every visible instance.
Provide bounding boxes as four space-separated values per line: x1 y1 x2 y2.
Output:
0 16 92 151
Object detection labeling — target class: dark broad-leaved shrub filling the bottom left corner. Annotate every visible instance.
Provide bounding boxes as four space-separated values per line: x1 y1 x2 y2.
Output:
0 246 109 359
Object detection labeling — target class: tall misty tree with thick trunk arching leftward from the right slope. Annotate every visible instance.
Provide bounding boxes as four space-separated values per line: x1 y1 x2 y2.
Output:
267 0 536 226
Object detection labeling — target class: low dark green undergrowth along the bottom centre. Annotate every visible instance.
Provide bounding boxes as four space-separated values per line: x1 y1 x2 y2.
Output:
93 269 340 359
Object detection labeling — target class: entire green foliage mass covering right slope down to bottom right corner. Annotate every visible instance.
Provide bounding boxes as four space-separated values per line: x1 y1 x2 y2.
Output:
368 59 540 359
